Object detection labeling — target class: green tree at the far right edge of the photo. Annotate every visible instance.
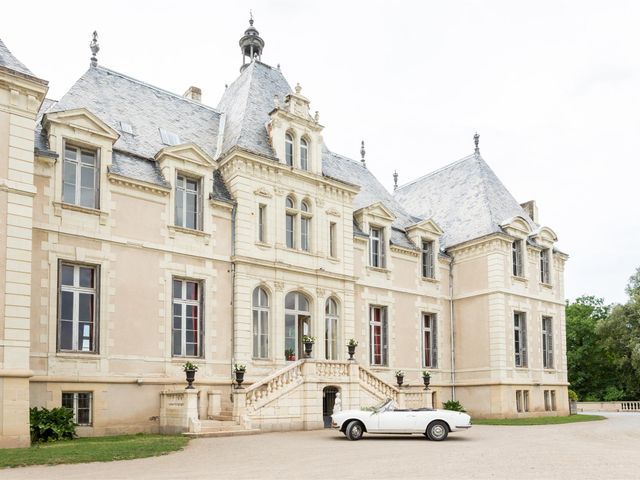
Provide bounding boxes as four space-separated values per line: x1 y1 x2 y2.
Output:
597 268 640 400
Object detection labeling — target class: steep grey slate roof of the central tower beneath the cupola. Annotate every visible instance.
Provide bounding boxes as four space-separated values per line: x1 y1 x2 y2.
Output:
218 61 291 159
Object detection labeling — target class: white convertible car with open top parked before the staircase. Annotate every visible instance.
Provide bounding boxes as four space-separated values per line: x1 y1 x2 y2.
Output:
331 399 471 442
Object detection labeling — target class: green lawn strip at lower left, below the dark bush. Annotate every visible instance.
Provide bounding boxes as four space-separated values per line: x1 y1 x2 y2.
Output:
0 434 189 466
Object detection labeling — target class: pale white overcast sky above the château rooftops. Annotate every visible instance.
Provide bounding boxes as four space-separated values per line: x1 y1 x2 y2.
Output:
0 0 640 302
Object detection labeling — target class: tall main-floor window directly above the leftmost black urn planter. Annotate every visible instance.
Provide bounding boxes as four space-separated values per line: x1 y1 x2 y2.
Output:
171 278 202 357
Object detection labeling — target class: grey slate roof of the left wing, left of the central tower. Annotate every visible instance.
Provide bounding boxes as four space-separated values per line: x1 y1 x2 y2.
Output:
50 67 220 158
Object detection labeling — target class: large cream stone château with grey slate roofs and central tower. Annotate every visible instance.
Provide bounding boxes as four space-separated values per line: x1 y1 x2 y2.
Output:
0 20 568 447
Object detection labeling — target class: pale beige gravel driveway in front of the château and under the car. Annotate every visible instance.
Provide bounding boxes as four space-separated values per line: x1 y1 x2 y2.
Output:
5 413 640 480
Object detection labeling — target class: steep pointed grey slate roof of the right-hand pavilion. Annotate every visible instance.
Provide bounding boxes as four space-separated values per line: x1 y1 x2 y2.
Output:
394 154 537 247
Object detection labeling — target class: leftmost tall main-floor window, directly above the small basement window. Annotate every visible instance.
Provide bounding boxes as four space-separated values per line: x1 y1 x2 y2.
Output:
58 263 98 352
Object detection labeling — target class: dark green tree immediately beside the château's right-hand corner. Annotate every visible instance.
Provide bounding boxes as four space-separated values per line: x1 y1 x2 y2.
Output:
566 296 616 400
